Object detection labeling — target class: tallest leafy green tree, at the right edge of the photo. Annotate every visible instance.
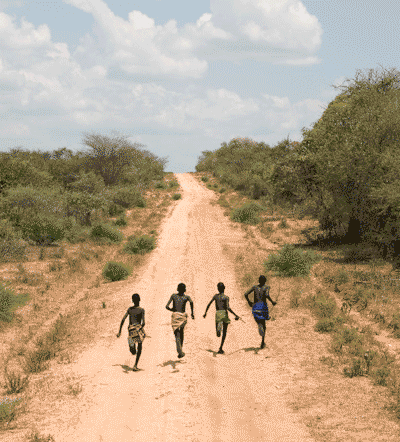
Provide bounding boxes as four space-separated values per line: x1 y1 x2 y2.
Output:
302 65 400 242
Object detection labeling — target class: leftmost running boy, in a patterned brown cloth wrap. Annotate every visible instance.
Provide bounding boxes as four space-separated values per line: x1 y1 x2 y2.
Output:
117 293 146 371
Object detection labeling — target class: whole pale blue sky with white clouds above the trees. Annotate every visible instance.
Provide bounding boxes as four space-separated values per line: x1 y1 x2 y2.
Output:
0 0 400 172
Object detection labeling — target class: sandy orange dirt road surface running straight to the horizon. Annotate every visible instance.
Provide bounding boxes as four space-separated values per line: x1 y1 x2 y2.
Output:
33 174 313 442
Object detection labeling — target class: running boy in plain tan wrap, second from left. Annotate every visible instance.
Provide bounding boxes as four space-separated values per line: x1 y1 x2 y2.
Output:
165 282 194 358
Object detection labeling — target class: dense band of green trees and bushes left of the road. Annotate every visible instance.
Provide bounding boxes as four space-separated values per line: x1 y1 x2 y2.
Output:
0 134 167 261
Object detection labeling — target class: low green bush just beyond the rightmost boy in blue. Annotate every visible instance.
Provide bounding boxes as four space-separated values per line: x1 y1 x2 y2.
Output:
264 244 321 276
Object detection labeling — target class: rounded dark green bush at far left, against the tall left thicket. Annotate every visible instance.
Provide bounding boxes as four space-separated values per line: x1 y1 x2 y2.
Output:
20 214 65 244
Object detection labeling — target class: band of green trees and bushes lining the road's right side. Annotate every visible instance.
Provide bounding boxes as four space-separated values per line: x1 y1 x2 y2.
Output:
196 68 400 255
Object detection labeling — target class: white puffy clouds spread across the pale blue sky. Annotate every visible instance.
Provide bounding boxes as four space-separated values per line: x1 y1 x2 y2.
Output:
0 0 323 150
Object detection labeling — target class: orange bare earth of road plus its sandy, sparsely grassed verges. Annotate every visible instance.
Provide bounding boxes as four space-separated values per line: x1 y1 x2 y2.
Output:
6 174 398 442
